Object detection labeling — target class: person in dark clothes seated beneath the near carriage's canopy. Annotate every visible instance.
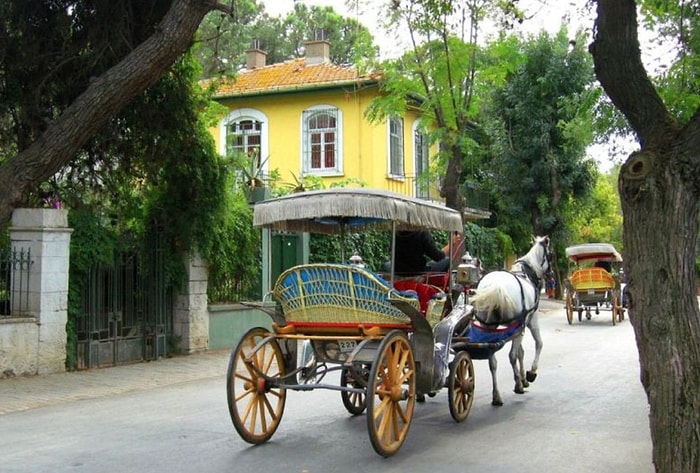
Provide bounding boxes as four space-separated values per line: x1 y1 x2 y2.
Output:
394 230 464 276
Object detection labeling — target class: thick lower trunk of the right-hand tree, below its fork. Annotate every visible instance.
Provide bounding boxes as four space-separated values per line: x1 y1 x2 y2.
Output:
620 150 700 473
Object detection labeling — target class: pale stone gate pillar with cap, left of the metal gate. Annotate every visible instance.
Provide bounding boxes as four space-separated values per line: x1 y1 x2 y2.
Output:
10 209 72 374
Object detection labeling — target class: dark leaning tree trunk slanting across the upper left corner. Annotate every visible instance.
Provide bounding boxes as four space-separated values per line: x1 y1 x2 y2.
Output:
0 0 224 222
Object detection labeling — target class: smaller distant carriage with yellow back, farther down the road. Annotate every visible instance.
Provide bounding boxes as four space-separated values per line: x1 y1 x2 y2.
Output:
565 243 625 325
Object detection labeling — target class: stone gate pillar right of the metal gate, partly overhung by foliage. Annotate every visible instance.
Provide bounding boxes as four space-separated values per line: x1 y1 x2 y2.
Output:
173 255 209 353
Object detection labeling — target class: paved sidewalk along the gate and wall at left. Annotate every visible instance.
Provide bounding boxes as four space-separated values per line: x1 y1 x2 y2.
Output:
0 350 230 416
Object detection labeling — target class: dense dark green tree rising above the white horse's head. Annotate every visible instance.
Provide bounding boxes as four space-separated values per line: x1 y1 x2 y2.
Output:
482 29 599 248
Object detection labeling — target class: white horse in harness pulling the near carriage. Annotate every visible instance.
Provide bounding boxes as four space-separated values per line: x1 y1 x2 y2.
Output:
469 236 551 406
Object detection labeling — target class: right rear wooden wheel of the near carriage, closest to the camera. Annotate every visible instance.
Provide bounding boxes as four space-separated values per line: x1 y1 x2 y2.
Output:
367 331 416 457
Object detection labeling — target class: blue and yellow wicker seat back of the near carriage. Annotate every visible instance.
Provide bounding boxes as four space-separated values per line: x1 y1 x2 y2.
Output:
272 264 420 335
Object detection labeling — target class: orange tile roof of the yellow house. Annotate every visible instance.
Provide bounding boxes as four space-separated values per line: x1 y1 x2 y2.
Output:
208 58 381 98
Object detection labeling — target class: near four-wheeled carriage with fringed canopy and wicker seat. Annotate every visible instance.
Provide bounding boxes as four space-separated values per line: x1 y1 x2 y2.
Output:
227 189 548 456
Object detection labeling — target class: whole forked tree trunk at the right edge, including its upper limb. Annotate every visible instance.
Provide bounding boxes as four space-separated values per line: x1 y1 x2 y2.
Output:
591 0 700 473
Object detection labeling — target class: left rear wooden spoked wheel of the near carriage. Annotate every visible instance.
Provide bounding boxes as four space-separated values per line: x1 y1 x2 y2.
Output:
226 327 287 444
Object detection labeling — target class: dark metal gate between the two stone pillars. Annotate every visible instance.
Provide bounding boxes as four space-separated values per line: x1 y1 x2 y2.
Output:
77 238 173 369
